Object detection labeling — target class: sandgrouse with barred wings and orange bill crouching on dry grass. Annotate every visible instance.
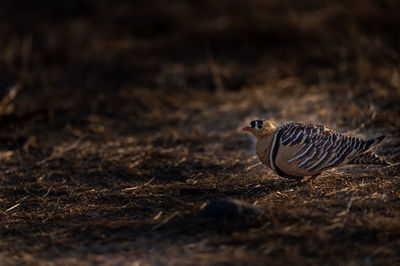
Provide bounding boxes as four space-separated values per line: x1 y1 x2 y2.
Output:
242 120 388 179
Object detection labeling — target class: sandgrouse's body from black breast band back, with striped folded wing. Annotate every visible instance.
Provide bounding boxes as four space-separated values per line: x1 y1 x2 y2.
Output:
270 123 384 178
